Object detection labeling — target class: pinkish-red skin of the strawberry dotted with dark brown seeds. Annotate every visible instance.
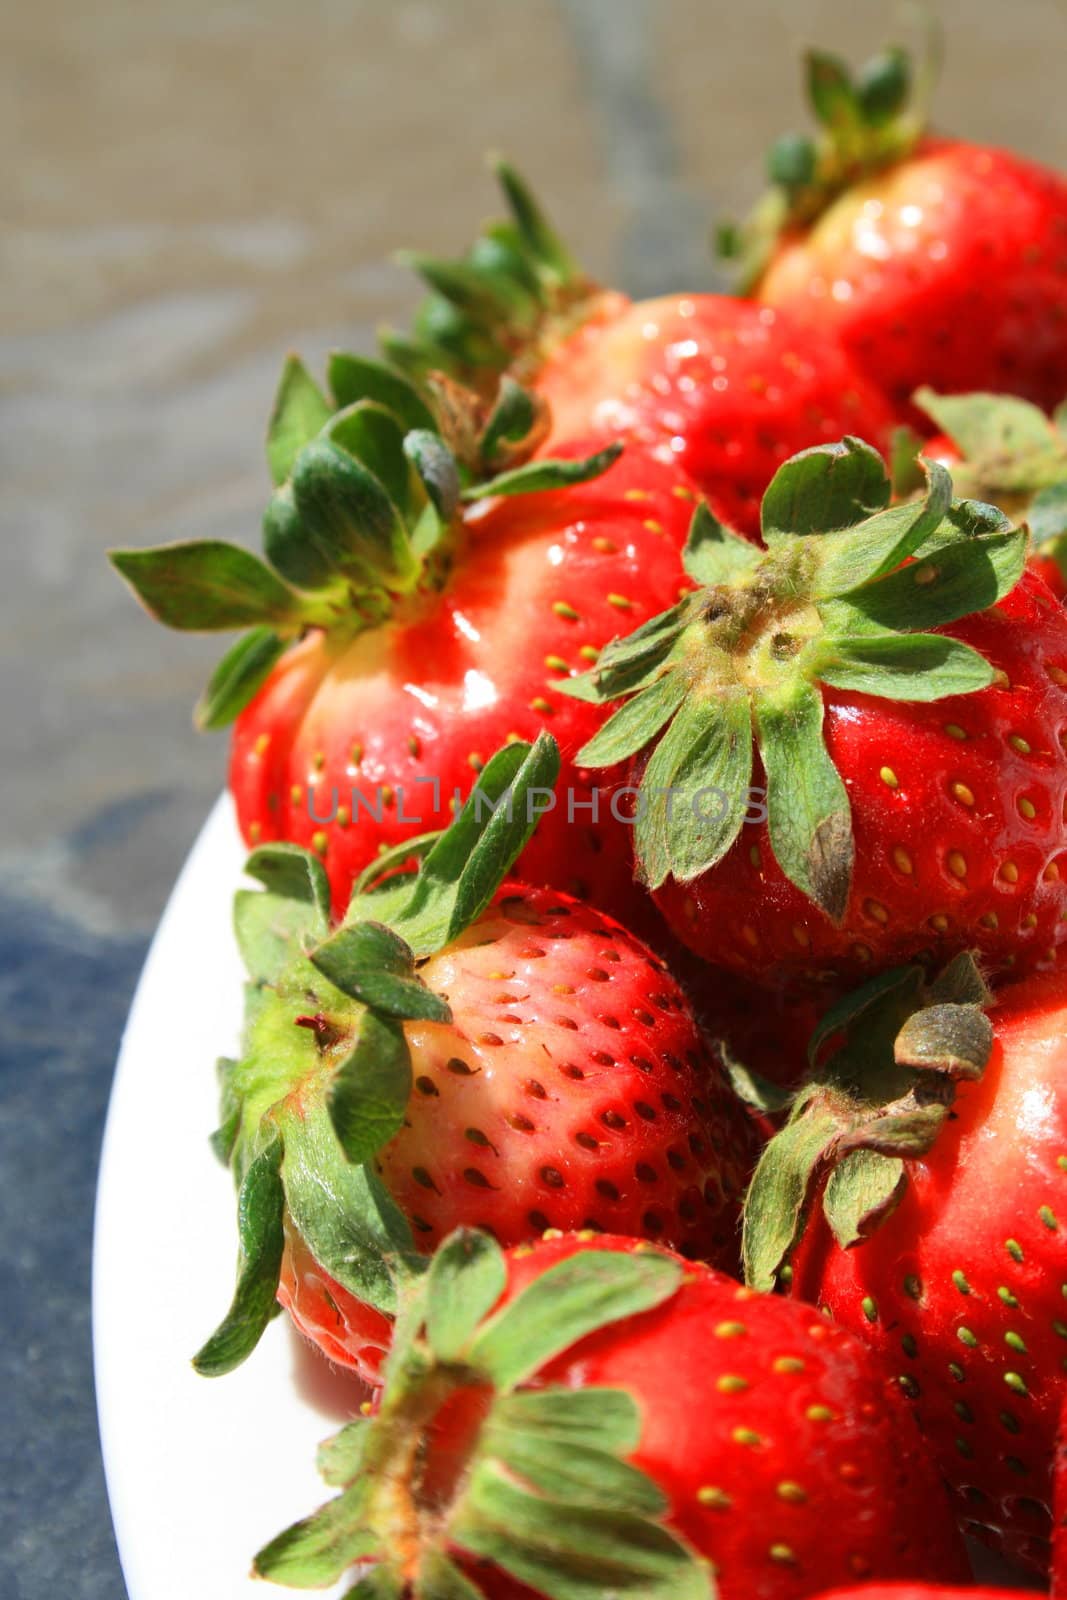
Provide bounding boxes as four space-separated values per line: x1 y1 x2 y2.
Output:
280 885 757 1382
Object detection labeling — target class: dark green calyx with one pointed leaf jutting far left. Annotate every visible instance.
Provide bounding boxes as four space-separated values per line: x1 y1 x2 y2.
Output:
110 352 621 728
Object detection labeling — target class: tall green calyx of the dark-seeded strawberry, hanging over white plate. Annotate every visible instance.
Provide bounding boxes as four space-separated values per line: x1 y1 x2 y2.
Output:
194 734 560 1376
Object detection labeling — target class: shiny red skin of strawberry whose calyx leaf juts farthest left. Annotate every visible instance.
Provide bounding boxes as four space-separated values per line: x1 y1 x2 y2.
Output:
230 446 694 926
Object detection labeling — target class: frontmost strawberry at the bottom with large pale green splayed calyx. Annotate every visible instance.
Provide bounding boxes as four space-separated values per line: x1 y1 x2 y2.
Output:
254 1232 966 1600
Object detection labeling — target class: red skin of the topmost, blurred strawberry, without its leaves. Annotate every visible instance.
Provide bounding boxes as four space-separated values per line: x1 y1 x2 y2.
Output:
755 139 1067 408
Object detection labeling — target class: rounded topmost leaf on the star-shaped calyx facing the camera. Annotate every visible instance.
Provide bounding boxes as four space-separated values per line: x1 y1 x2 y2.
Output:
760 435 891 549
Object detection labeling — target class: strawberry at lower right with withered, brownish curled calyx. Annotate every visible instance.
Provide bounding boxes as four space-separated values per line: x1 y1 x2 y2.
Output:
745 955 1067 1571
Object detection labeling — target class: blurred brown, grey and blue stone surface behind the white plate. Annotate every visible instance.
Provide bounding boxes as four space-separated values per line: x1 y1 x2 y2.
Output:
0 0 1067 1600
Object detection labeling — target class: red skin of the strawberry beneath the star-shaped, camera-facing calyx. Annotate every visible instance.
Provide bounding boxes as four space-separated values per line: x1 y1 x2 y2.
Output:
656 574 1067 986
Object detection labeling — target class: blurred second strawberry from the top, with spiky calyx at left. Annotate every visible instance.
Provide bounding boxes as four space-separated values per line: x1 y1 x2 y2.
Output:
386 165 896 536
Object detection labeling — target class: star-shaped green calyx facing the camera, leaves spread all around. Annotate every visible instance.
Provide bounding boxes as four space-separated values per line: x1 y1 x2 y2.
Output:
557 438 1027 922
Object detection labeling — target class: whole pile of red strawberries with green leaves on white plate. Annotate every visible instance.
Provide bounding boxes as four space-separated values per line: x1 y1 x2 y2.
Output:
112 34 1067 1600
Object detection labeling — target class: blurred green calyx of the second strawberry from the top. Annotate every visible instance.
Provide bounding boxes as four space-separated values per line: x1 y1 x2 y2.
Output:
382 160 601 389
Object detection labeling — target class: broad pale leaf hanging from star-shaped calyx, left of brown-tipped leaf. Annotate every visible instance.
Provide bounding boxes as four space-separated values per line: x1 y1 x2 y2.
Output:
639 690 752 890
